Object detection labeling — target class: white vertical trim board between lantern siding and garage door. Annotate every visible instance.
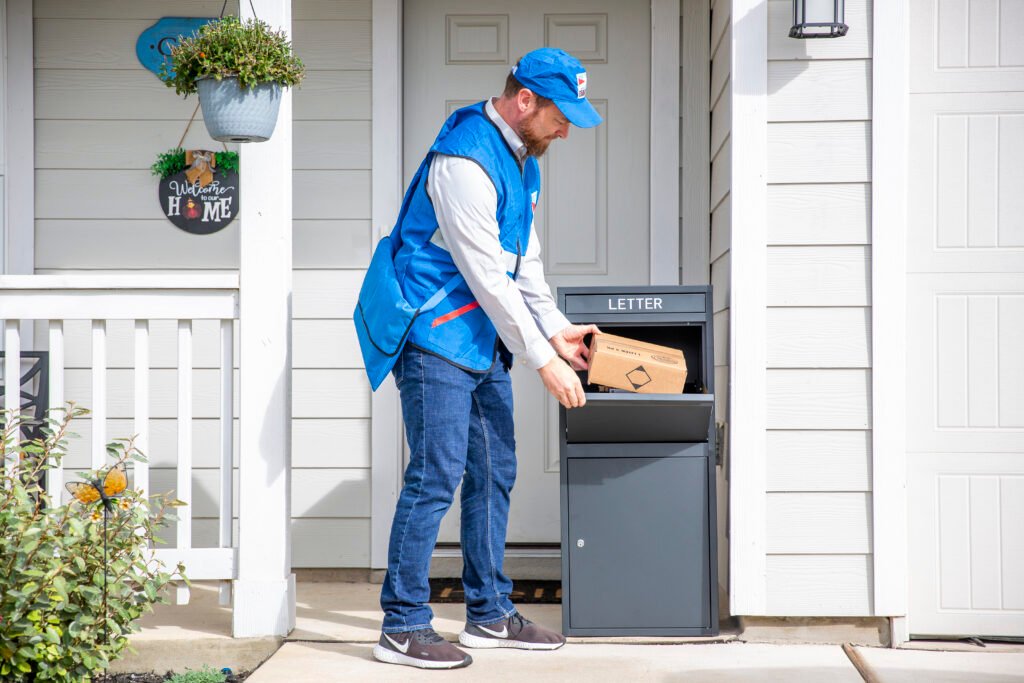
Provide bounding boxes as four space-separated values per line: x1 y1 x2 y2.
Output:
871 0 910 624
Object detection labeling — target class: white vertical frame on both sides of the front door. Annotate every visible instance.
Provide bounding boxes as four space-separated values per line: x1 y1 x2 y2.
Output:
370 0 696 569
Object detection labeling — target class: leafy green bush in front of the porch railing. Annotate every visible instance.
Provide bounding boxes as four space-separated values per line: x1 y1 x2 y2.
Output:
0 403 184 683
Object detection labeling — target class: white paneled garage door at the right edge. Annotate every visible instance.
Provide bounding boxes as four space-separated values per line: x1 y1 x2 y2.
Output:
905 0 1024 637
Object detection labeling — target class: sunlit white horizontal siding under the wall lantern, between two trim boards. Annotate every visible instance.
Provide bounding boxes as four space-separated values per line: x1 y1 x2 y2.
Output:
765 0 872 616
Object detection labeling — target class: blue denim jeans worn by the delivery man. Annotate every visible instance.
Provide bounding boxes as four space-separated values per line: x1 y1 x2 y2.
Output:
381 344 516 633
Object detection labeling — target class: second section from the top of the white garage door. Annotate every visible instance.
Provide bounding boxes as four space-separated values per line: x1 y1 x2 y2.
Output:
907 93 1024 272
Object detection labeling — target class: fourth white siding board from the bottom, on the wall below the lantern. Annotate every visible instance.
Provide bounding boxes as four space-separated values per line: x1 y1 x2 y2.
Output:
766 370 871 429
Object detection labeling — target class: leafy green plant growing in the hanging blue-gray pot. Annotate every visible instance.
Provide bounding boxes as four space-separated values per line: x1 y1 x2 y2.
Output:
160 16 305 95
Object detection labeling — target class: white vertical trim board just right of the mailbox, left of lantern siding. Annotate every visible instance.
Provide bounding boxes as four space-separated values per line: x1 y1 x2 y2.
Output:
728 0 768 615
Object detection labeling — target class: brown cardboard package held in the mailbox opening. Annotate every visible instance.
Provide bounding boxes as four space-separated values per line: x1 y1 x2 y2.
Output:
587 333 686 393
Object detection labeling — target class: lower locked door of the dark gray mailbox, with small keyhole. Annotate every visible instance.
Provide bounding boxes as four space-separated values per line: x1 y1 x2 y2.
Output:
563 446 711 629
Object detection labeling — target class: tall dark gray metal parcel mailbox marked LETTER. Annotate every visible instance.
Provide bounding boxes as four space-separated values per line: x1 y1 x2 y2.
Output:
558 287 718 636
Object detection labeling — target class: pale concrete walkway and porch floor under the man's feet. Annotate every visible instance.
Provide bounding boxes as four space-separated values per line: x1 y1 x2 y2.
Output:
119 582 1024 683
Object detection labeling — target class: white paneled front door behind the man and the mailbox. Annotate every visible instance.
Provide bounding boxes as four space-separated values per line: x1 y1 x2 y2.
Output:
403 0 650 544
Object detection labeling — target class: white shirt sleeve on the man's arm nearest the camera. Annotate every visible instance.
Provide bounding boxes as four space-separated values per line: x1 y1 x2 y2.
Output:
427 155 556 370
